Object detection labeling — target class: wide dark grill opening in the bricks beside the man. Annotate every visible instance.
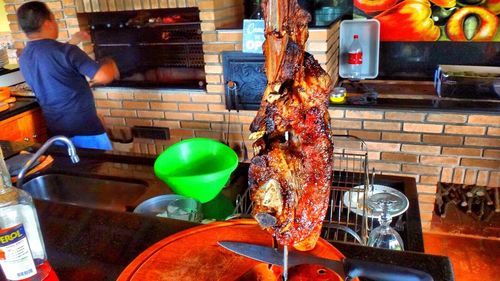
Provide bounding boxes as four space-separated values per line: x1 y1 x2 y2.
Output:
78 8 206 88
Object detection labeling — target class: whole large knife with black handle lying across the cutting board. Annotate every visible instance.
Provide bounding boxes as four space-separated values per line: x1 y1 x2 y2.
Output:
218 241 434 281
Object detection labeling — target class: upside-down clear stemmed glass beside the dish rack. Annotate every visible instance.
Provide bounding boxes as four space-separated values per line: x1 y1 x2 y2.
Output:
367 192 405 250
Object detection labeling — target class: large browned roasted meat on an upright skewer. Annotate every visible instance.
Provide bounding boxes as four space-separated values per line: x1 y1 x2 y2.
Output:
249 0 333 251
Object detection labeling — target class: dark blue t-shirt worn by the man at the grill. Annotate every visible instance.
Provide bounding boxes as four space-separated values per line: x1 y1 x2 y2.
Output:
19 39 105 137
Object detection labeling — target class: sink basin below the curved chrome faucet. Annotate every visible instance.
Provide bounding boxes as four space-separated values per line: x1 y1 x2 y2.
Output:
23 174 148 211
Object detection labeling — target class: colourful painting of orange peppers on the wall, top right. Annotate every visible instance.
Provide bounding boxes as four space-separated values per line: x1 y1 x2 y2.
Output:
354 0 500 42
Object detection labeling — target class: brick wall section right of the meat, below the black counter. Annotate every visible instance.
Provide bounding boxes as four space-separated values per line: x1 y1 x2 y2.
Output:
330 109 500 229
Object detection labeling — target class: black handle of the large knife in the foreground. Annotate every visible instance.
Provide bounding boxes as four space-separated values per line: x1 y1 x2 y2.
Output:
343 258 434 281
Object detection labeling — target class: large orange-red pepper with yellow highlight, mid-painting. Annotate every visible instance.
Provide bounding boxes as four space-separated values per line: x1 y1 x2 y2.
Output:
374 0 441 41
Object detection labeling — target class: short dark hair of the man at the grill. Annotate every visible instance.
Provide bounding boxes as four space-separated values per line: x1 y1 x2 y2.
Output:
17 1 52 34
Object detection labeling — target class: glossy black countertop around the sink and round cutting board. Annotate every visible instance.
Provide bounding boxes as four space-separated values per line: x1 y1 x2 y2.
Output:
1 145 454 280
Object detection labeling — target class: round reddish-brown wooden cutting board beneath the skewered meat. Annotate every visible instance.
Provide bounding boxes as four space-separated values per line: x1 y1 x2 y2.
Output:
117 220 344 281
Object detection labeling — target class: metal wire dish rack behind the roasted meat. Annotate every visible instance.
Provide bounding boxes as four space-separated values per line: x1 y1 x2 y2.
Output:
231 135 371 244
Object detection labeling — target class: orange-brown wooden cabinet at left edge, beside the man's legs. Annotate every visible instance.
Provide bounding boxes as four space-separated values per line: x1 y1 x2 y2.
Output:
0 108 47 143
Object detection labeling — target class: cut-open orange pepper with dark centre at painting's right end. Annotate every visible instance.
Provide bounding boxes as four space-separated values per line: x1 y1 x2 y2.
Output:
446 6 498 41
